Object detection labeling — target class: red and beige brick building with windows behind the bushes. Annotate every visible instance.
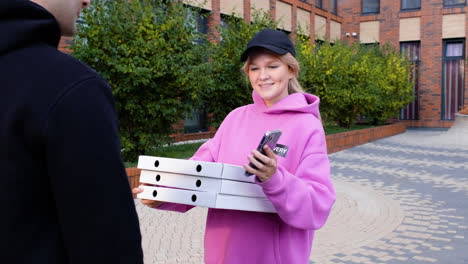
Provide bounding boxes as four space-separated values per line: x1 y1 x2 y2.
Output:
64 0 468 127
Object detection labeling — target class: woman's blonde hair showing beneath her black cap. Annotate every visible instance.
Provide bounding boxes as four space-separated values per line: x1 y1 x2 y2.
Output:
242 49 304 94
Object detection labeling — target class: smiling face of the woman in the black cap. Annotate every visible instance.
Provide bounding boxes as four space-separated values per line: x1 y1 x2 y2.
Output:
247 52 293 107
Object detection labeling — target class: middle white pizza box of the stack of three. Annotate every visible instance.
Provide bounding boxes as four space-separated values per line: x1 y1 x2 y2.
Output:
140 170 265 197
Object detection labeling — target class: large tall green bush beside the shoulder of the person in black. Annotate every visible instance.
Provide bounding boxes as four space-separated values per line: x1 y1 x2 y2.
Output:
72 0 207 160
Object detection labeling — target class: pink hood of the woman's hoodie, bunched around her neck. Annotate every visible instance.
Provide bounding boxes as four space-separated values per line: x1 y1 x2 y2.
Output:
252 91 320 119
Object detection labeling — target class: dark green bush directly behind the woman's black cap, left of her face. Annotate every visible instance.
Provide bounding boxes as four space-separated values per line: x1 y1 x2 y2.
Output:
200 11 276 126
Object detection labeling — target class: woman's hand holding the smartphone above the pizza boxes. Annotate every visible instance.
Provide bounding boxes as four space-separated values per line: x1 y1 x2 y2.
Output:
244 145 277 182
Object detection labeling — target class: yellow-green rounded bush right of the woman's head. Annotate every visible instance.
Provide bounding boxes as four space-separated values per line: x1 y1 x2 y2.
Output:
297 39 411 128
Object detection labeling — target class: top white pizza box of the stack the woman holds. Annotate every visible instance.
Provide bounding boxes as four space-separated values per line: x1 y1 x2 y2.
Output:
137 156 255 183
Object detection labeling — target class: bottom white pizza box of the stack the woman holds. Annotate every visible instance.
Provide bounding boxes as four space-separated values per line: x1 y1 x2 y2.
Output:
137 186 276 213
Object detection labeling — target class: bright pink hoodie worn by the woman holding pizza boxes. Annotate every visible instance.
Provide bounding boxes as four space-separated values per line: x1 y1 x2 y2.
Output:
158 92 335 264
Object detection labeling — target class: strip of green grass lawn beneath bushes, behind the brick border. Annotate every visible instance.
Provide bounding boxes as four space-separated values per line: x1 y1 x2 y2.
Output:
125 125 380 168
